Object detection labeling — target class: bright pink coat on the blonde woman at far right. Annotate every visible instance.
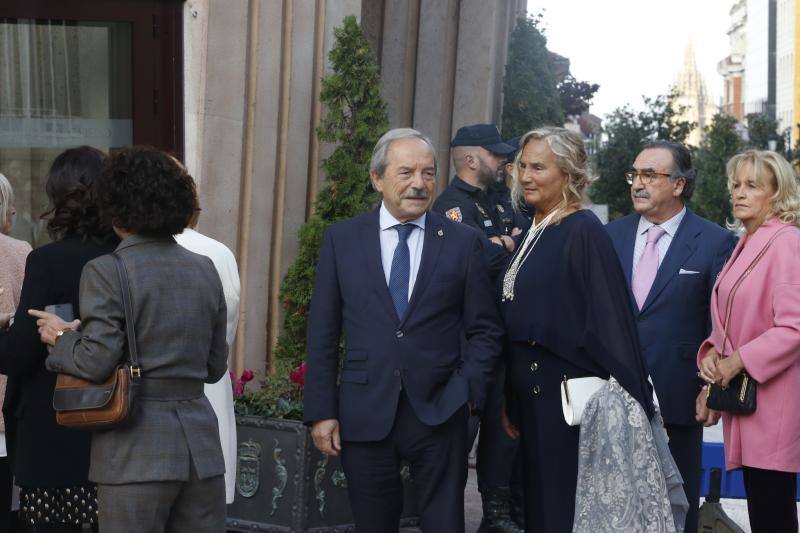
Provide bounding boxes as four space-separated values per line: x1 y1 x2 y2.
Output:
697 218 800 472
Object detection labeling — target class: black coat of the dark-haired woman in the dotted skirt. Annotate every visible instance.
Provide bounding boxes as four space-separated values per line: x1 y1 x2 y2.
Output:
0 237 117 488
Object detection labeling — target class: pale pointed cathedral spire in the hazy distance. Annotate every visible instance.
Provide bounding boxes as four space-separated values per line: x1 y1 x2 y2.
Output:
674 41 717 146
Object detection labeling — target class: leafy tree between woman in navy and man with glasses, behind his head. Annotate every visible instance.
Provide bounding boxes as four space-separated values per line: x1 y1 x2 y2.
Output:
589 93 694 220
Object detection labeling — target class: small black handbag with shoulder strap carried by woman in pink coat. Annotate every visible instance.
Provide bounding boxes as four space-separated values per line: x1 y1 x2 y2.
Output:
706 230 783 415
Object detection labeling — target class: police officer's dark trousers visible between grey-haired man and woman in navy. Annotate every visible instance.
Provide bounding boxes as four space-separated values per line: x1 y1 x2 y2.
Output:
475 364 521 494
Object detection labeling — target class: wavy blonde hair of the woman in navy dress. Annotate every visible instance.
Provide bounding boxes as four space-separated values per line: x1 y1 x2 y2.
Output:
511 126 593 210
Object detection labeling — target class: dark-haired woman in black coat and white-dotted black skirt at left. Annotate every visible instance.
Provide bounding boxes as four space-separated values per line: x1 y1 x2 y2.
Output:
0 146 119 532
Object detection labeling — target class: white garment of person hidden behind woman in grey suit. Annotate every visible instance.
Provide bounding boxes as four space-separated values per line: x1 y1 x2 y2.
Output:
175 228 240 503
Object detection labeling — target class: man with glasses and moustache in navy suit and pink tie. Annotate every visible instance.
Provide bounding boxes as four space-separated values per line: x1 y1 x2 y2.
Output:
607 141 736 533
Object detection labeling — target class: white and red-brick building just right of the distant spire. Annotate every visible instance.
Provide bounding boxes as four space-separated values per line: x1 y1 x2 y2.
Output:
717 0 747 122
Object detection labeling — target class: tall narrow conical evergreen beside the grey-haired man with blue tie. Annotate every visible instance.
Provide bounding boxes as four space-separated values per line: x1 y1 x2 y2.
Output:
275 16 388 366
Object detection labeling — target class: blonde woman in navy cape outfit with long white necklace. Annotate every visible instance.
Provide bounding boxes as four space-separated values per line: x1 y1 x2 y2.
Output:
501 128 654 533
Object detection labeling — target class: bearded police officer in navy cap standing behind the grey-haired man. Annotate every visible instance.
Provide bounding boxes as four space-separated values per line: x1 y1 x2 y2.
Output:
433 124 521 533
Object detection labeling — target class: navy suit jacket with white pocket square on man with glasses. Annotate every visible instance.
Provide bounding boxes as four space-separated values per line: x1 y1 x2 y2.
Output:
606 208 736 425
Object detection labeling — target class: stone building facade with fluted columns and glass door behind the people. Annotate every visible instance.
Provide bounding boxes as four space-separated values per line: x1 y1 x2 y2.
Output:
0 0 525 371
